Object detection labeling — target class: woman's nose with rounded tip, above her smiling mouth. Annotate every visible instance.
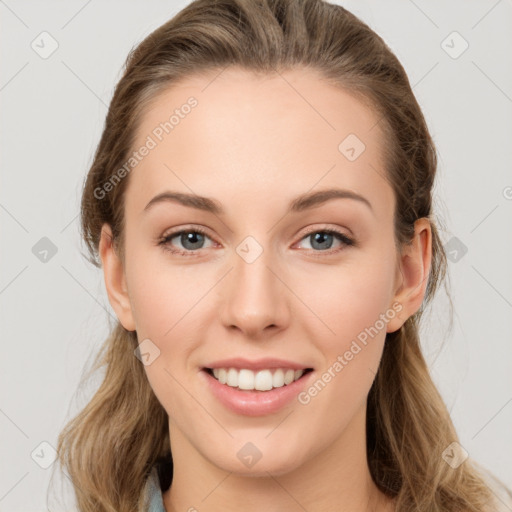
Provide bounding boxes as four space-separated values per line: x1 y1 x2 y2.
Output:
220 247 290 340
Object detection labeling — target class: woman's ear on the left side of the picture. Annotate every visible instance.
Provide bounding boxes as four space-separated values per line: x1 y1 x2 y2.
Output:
99 224 135 331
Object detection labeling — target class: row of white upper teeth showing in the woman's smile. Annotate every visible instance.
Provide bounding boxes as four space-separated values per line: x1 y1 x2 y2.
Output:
209 368 304 391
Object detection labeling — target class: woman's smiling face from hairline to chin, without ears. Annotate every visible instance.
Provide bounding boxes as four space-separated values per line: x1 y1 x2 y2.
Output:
102 68 426 475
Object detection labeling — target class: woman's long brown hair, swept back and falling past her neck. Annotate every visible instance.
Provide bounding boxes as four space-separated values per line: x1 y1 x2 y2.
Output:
52 0 508 512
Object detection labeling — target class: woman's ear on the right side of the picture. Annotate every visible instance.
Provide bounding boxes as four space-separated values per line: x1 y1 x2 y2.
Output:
387 217 432 332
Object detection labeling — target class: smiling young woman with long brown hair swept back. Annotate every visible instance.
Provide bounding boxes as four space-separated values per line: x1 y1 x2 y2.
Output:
54 0 508 512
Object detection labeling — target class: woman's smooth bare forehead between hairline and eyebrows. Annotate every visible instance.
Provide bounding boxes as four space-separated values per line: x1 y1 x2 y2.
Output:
129 64 391 216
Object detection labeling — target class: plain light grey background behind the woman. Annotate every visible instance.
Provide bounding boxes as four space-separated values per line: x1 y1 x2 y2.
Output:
0 0 512 512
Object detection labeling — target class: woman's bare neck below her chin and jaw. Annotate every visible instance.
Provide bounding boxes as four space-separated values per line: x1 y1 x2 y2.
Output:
163 409 393 512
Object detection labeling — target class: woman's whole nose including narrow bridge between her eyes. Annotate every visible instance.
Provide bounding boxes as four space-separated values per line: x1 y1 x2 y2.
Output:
222 236 288 336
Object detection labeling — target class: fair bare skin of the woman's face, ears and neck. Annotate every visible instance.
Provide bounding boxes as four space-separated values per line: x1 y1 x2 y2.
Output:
100 68 431 512
